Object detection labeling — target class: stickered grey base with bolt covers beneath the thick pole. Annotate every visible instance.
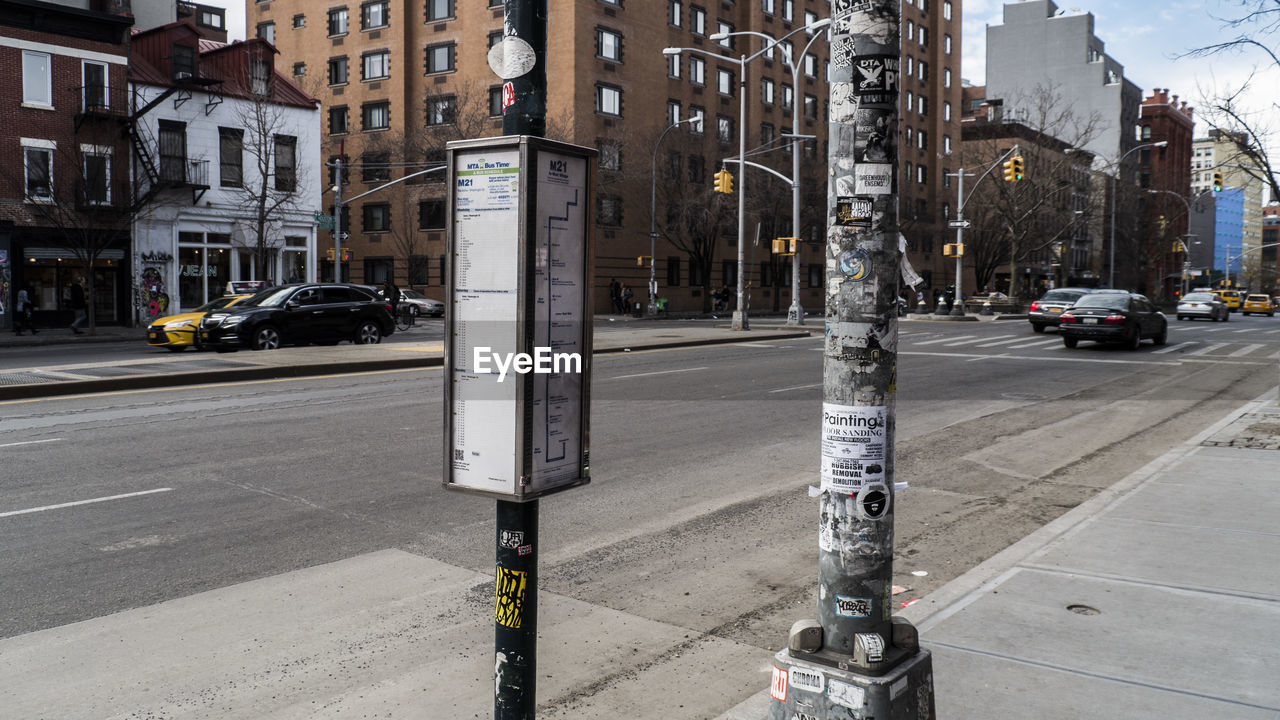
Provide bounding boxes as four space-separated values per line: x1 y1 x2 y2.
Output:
768 640 936 720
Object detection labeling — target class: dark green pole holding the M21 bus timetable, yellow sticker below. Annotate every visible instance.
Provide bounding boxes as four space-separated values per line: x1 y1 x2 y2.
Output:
493 0 547 720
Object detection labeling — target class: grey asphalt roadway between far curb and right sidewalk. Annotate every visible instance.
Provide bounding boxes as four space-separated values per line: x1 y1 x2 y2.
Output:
0 316 1280 717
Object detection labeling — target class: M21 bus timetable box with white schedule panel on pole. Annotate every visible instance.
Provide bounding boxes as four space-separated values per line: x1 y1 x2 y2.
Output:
444 136 595 501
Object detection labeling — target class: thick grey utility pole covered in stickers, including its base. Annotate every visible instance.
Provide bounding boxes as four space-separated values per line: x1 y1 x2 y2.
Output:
769 0 934 720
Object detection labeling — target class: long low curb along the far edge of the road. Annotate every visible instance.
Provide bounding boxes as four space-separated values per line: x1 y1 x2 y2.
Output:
0 332 812 401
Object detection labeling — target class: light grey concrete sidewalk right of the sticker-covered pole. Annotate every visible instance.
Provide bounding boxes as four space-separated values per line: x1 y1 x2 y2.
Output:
719 391 1280 720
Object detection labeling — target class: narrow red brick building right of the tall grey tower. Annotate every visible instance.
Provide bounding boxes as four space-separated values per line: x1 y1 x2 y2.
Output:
1138 87 1196 297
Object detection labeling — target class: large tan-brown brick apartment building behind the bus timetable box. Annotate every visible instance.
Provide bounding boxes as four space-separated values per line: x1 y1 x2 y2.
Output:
246 0 961 313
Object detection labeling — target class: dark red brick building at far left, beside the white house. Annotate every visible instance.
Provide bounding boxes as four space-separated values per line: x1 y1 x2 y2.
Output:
0 0 133 329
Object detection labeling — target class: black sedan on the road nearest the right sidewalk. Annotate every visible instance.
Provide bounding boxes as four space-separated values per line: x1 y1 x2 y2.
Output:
1057 292 1169 350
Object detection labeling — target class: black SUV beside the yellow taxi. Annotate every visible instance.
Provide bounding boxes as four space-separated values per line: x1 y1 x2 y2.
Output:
200 283 396 350
